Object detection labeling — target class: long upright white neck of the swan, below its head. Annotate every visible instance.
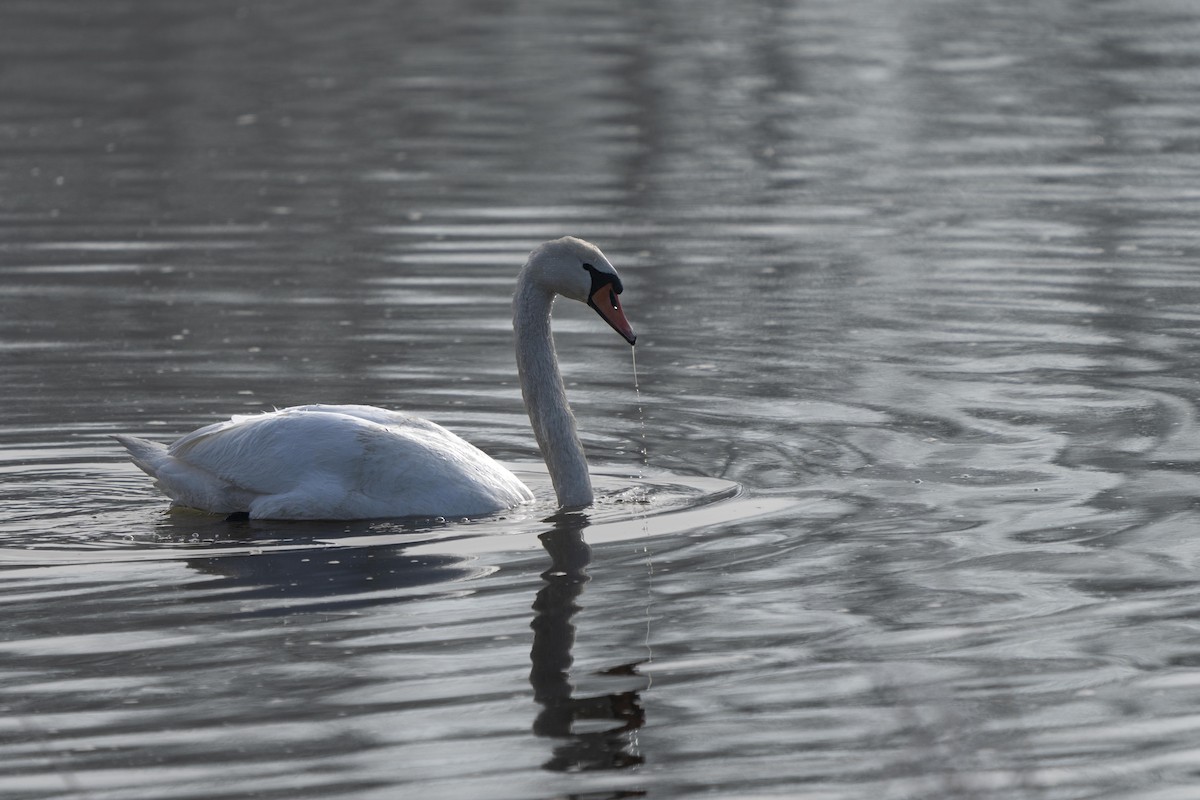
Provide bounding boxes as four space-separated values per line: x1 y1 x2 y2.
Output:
512 270 592 509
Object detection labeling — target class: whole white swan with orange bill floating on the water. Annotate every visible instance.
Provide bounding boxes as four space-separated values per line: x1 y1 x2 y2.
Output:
116 236 637 519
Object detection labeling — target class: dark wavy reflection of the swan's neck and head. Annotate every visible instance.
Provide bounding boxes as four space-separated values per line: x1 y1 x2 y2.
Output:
529 513 646 771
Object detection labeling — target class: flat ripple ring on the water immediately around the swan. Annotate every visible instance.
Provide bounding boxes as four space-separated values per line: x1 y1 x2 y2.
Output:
0 450 796 565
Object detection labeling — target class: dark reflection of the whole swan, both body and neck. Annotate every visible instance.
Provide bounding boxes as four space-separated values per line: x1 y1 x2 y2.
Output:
176 513 647 777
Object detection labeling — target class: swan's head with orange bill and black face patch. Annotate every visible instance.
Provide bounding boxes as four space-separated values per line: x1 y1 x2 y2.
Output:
526 236 637 344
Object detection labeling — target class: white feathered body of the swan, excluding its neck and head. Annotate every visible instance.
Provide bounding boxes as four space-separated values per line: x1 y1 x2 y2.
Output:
121 405 533 519
